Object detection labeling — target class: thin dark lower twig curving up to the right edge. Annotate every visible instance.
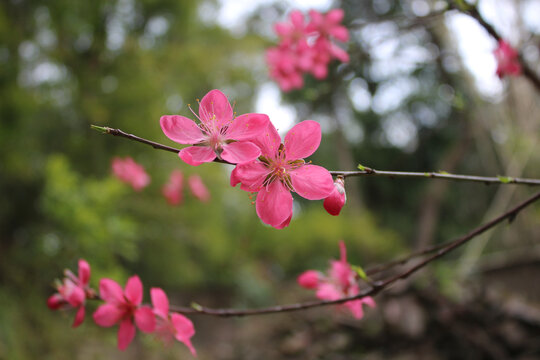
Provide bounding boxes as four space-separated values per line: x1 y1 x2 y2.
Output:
171 192 540 317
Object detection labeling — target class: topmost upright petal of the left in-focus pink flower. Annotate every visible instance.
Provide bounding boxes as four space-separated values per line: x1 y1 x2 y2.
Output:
199 89 233 129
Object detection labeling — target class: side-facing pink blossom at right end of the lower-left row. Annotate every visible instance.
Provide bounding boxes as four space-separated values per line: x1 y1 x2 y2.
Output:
150 288 197 356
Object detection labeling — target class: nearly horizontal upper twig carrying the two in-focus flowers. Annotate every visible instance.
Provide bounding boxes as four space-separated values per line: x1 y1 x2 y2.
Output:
90 125 540 186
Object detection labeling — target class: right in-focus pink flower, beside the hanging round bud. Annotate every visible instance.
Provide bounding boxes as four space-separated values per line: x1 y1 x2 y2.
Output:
231 120 334 229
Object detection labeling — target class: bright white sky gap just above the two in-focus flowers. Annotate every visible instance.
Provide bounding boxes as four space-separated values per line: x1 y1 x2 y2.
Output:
255 83 296 136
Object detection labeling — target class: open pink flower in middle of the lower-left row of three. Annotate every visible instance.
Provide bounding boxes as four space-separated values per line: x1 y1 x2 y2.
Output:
93 276 156 350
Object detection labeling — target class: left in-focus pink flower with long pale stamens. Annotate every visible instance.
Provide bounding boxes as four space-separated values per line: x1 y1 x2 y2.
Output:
159 90 269 166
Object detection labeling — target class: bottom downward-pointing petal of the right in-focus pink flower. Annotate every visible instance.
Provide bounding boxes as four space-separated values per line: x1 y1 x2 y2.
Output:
255 181 292 227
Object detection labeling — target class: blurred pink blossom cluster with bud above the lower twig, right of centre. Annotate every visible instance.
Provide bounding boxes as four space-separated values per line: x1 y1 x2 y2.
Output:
298 241 375 319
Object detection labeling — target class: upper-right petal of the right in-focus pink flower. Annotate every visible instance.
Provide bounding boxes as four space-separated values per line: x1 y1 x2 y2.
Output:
283 120 321 160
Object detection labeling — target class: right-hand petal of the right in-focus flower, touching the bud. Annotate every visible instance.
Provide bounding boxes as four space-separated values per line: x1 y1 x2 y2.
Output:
290 165 334 200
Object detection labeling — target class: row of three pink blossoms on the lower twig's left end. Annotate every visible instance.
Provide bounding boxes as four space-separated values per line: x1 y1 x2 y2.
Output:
47 259 196 356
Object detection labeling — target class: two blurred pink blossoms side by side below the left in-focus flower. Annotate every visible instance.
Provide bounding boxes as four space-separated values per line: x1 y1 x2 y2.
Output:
161 170 210 205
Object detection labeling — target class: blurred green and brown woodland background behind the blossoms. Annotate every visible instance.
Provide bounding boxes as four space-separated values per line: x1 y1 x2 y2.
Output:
0 0 540 359
